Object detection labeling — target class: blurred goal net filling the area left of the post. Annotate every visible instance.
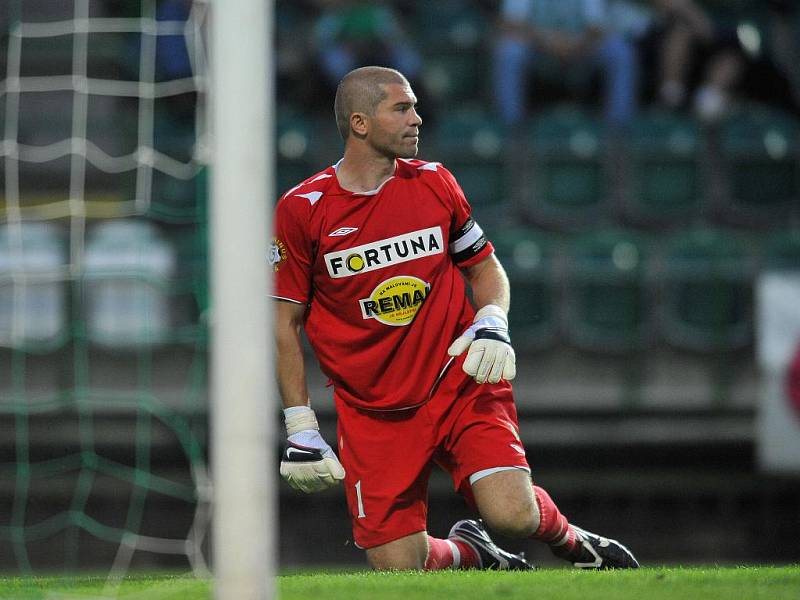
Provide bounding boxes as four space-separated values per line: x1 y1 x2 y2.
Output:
0 0 211 577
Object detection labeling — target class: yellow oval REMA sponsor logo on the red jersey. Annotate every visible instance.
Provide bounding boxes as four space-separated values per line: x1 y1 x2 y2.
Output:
359 275 431 327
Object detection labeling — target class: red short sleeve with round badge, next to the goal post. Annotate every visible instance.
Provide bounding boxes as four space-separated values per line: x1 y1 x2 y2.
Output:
269 196 314 304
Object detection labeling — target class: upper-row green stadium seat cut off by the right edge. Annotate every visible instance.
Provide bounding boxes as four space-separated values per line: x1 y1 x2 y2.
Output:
720 107 800 226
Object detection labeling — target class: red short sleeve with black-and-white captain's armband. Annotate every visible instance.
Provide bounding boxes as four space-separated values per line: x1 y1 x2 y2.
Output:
438 167 494 268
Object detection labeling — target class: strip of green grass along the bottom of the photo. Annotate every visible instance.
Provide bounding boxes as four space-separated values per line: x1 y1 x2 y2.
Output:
0 565 800 600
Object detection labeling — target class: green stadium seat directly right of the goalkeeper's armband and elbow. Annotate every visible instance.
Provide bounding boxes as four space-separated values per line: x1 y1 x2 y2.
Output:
487 229 559 351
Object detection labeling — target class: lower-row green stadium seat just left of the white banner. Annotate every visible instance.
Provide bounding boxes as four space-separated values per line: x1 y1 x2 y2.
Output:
659 228 757 352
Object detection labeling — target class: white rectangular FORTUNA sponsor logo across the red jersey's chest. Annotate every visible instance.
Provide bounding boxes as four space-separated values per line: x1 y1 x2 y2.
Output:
325 227 445 279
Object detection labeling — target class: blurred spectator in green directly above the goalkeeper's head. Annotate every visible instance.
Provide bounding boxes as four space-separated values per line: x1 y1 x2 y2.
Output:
314 0 422 87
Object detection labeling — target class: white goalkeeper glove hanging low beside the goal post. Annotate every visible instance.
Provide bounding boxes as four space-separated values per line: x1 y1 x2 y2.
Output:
281 406 344 494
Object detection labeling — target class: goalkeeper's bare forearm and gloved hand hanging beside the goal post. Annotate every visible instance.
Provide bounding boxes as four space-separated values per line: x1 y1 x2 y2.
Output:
275 301 344 492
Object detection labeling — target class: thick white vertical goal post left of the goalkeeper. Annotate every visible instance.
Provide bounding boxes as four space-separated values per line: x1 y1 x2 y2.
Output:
210 0 278 600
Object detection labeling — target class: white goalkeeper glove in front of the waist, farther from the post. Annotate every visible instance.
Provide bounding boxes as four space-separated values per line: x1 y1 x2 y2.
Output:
447 304 517 383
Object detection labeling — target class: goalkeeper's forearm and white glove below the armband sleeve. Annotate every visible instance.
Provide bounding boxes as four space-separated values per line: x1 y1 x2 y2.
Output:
447 255 517 383
